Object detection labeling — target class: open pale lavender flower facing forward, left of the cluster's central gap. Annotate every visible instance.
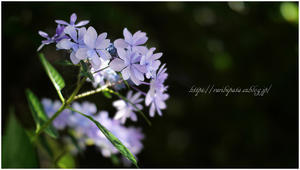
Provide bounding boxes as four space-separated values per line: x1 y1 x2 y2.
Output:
76 27 111 69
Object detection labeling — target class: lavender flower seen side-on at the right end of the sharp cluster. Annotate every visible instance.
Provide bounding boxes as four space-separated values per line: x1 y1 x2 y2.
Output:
145 64 169 117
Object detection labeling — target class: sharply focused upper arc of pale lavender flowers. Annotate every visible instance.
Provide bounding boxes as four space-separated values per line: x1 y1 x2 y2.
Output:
38 13 169 123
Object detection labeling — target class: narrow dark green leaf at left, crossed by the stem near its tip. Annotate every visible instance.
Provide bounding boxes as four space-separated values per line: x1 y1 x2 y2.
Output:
26 89 58 138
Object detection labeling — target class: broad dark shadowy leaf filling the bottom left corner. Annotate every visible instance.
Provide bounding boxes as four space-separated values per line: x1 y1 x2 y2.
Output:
2 108 39 168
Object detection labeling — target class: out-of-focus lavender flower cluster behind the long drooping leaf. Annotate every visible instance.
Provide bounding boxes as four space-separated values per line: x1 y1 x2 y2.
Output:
42 98 144 163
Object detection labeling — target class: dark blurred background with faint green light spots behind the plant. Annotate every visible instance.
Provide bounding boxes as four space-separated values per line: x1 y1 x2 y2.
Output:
2 2 298 168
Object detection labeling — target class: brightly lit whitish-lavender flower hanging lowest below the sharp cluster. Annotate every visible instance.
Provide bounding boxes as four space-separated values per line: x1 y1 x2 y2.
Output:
113 91 143 124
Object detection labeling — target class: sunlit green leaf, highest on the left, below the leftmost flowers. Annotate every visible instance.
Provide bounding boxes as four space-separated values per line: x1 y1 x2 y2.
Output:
40 53 65 102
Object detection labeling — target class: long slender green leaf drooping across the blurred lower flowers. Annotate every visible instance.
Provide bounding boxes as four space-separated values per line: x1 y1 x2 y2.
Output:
68 107 138 167
